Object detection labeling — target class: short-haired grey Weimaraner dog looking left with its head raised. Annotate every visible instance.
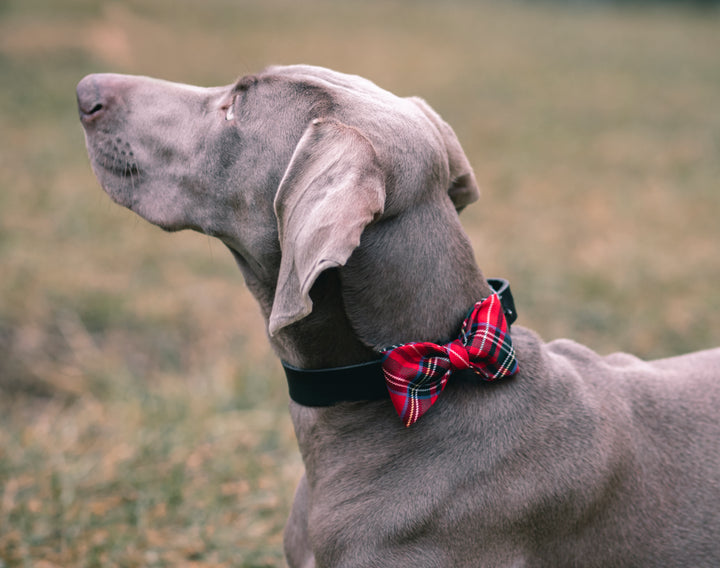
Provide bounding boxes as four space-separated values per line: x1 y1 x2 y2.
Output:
77 66 720 568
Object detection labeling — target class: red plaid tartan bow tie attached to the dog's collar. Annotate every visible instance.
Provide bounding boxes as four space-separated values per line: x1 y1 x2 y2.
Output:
382 294 517 426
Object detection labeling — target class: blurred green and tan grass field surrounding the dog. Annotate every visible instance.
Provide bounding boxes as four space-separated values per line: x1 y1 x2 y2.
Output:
0 0 720 568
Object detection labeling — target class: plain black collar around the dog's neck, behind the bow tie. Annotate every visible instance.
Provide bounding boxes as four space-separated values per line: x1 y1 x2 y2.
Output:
282 278 517 406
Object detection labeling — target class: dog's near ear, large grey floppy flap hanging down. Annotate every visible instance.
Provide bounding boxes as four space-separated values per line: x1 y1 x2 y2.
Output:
268 119 385 335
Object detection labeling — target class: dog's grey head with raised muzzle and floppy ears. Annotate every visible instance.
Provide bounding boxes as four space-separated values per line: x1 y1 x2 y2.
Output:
77 66 478 346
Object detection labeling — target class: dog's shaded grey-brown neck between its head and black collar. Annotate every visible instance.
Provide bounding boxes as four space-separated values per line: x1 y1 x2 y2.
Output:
238 206 491 369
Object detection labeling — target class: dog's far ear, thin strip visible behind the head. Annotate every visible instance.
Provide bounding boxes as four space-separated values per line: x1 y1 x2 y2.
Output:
409 97 480 212
